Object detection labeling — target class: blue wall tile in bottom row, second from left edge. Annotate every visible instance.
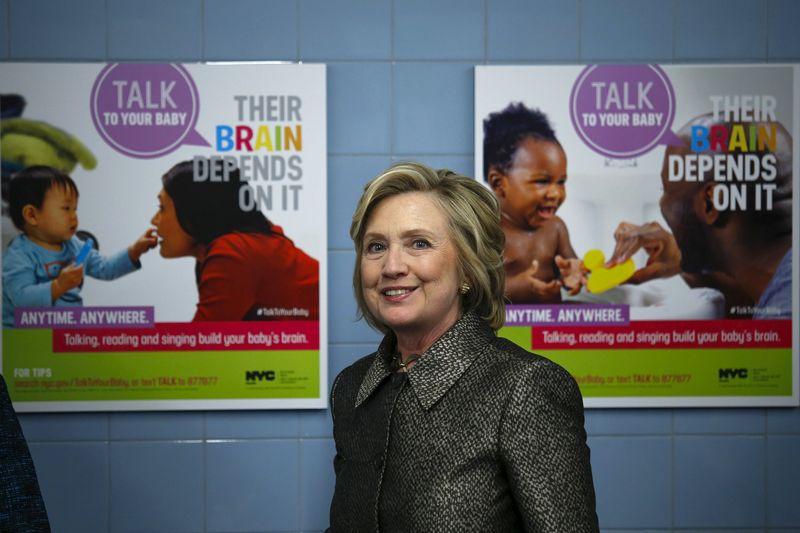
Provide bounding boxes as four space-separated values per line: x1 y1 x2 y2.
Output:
110 442 204 532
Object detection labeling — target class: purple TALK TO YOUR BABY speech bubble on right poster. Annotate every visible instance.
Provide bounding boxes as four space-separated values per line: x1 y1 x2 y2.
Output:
569 65 675 159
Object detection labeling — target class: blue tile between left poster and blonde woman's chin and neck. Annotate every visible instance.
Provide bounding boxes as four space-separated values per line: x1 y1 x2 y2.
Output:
328 252 382 346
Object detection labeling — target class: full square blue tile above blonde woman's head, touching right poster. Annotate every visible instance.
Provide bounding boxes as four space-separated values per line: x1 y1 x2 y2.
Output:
394 63 475 154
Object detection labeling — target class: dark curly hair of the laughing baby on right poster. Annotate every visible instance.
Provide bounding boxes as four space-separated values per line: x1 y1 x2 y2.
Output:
483 102 561 182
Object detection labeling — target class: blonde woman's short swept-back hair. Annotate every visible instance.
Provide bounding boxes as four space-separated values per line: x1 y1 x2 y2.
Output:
350 162 505 333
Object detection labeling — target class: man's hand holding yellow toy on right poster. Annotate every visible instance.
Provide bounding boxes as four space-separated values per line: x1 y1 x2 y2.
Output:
606 222 681 283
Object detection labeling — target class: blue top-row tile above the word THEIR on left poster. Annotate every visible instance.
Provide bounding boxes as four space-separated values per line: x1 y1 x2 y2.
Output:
203 0 297 61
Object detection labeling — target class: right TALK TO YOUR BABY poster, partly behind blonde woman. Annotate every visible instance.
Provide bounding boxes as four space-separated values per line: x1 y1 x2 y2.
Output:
475 65 800 407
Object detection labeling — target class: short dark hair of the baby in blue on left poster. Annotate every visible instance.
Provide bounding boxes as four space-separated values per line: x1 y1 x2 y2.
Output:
8 165 79 231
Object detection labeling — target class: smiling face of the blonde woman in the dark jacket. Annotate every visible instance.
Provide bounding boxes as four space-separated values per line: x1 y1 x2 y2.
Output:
361 192 461 339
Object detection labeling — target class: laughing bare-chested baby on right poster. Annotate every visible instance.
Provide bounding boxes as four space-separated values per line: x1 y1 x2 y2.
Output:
483 103 586 303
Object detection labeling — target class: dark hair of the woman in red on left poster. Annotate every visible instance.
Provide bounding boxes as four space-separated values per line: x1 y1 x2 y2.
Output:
161 158 275 244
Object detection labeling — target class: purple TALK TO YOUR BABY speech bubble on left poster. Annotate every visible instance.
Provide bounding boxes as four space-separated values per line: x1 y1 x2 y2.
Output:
91 63 200 159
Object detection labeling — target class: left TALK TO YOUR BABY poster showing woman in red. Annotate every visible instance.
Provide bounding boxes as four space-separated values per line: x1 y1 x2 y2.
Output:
0 63 327 412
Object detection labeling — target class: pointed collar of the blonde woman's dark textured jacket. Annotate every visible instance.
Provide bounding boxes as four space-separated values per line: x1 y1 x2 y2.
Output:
356 313 494 411
